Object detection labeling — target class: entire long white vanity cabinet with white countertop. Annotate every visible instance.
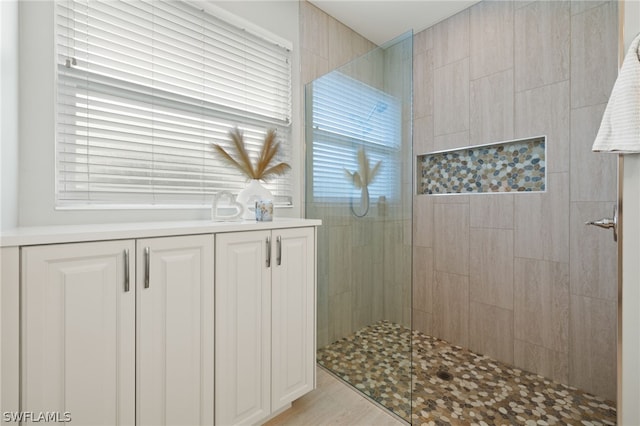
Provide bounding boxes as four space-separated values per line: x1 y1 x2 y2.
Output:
0 218 320 426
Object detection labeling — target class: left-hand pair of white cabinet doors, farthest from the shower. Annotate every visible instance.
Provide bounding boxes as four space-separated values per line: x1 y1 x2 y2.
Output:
21 235 213 425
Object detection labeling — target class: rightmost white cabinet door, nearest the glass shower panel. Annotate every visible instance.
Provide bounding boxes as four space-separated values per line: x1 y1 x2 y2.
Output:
271 228 315 412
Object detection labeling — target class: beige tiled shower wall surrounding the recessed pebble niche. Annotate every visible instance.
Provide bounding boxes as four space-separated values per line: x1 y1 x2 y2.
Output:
413 1 618 400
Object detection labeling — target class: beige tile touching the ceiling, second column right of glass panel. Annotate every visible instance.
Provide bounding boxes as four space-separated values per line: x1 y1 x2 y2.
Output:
433 9 469 68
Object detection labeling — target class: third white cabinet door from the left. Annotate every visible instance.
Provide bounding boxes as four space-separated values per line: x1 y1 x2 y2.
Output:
215 231 271 426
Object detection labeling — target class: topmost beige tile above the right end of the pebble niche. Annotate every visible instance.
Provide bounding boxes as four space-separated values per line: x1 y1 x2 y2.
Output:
514 1 571 92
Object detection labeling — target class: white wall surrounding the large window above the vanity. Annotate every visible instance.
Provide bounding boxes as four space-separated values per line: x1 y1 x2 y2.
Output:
16 1 304 226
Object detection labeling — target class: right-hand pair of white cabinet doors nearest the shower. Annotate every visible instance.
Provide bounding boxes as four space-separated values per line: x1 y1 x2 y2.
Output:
215 227 315 426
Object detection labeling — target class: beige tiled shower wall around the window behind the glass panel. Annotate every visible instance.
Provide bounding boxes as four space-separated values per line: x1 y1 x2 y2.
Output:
300 2 412 347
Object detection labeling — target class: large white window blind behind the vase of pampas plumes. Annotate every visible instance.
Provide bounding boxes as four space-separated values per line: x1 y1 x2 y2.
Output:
56 0 292 206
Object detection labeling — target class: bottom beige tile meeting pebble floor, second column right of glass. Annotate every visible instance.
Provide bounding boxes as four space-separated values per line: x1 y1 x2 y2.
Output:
432 271 469 347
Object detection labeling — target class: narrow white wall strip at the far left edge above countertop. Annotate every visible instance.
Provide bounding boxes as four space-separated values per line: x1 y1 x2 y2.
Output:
0 0 18 233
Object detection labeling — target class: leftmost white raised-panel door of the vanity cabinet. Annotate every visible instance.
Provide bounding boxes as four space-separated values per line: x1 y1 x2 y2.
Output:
21 241 135 425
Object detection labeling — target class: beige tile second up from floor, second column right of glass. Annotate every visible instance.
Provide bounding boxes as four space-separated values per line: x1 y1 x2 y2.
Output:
434 204 469 275
